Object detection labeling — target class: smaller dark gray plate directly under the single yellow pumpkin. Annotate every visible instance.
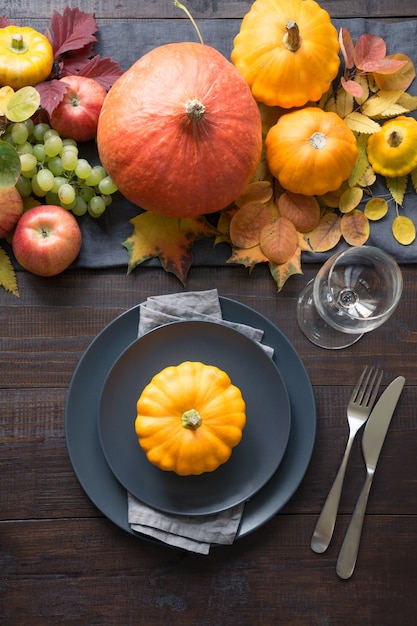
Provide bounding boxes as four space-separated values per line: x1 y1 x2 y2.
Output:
98 321 291 515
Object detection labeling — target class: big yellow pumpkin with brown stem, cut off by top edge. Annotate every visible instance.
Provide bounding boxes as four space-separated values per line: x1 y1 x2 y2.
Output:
232 0 340 109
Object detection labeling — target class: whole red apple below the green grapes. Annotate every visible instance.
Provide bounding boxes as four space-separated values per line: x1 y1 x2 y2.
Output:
12 204 82 276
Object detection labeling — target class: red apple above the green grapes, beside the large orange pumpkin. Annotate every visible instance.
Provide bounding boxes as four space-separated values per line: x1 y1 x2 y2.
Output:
51 76 107 142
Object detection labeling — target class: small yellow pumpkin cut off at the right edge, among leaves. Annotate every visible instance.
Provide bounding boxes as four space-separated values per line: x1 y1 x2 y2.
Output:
367 115 417 178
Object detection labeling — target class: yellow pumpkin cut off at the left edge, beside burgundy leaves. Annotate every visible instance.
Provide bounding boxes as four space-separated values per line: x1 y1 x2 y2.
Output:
0 26 54 90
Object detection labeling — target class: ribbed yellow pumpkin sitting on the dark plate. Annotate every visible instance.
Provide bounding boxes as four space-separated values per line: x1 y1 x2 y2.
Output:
135 361 246 476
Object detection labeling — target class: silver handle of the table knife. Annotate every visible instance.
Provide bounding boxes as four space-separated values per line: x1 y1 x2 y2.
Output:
336 472 374 580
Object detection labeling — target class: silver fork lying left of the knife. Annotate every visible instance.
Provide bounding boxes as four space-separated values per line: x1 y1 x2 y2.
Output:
311 366 383 553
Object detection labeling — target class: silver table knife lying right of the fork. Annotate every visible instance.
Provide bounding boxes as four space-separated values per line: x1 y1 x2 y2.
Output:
336 376 405 579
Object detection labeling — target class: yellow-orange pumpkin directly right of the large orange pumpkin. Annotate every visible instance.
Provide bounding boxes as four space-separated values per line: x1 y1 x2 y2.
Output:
265 107 358 196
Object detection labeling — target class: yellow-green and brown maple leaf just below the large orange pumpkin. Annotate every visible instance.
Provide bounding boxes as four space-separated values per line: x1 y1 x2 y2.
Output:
122 211 218 286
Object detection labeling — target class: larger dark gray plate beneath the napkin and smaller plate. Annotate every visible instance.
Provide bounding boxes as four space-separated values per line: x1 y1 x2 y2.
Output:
65 298 316 538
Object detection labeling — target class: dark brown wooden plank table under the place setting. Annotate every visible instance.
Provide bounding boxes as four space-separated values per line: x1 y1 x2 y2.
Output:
0 0 417 626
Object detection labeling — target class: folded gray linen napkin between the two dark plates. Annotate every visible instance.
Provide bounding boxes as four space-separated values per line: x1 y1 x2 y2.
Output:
128 289 274 554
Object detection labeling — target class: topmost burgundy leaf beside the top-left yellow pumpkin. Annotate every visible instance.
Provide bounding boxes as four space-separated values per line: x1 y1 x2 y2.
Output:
45 6 98 60
